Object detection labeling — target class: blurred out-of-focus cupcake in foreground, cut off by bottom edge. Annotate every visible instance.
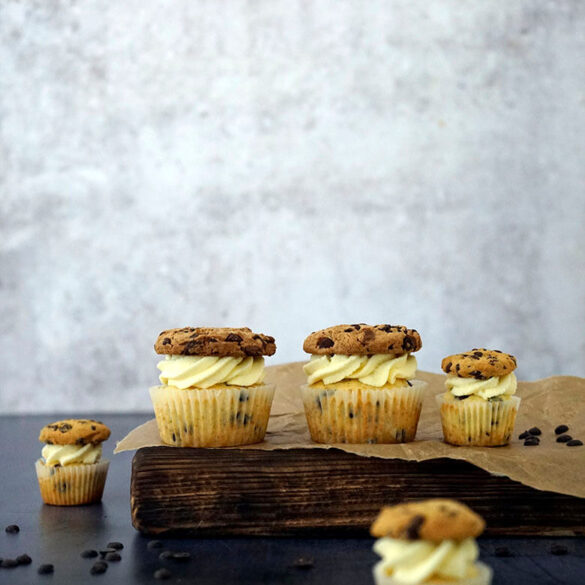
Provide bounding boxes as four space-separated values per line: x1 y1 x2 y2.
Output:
370 499 492 585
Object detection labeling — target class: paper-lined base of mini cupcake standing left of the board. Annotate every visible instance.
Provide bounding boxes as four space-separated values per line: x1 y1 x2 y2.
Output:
35 459 110 506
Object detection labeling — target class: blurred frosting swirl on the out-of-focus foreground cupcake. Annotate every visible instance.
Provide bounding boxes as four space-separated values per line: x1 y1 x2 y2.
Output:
374 537 479 585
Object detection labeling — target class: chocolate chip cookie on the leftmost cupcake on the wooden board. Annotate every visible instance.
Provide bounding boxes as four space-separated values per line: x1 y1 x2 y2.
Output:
154 327 276 357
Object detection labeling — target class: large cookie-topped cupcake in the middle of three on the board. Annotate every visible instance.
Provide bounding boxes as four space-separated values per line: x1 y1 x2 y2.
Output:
301 323 427 443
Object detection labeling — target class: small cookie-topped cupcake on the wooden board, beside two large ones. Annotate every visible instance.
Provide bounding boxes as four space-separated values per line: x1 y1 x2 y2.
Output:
437 349 520 447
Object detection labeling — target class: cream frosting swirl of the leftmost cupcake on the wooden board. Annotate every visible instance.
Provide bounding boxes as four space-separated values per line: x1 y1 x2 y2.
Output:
156 355 264 389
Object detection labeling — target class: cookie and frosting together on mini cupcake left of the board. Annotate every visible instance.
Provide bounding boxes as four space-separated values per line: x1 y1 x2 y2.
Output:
39 418 110 467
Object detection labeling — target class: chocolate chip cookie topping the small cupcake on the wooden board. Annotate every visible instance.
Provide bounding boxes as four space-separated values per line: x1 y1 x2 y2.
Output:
441 348 516 380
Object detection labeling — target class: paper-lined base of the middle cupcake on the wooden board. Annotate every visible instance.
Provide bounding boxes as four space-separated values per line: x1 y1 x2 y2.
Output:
301 380 427 443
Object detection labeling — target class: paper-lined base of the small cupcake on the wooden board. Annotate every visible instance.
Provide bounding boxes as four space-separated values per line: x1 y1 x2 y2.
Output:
436 394 520 447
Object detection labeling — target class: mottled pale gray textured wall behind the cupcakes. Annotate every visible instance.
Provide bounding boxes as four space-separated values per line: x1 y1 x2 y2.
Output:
0 0 585 412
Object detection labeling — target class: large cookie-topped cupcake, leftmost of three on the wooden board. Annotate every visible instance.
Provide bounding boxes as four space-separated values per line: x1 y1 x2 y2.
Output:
150 327 276 447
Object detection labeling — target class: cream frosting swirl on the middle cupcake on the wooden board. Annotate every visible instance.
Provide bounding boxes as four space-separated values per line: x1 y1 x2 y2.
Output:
303 353 417 387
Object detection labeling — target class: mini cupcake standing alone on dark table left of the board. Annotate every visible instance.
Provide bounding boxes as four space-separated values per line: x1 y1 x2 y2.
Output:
36 419 110 506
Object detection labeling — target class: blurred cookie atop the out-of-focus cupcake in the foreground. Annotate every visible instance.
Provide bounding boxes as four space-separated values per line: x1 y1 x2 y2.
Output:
370 499 485 543
